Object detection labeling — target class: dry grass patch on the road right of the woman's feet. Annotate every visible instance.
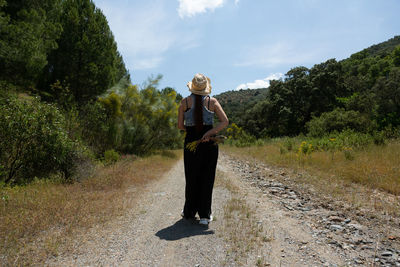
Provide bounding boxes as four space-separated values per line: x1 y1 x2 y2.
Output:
216 171 272 266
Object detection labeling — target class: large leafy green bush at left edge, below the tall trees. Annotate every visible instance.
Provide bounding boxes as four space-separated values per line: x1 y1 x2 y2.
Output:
0 95 78 183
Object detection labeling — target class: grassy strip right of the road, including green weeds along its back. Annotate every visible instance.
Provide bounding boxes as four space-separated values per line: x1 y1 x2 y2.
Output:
224 129 400 195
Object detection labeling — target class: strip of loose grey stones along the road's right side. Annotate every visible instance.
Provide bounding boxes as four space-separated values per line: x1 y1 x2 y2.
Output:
225 153 400 266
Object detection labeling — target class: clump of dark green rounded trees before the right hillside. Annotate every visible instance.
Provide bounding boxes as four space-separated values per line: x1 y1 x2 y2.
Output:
239 59 345 137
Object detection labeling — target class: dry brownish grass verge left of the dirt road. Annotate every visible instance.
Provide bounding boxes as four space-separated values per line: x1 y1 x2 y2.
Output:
0 152 178 266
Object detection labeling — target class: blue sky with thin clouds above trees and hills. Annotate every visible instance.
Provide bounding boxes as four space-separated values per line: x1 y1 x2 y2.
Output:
94 0 400 96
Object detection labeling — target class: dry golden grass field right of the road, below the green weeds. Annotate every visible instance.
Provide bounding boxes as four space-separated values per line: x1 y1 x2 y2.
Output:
224 138 400 195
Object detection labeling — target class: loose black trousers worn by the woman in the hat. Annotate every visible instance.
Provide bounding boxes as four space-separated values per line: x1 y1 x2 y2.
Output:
183 125 218 219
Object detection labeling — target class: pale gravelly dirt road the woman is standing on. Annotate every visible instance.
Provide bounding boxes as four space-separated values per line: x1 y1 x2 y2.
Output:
47 154 400 266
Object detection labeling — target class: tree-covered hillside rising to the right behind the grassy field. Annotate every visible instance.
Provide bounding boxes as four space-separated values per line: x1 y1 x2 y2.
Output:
215 36 400 131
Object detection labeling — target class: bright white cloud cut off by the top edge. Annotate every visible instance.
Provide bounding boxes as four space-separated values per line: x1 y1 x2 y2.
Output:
178 0 225 18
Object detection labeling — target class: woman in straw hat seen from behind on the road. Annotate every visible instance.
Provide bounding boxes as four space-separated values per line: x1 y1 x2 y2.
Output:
178 73 229 225
